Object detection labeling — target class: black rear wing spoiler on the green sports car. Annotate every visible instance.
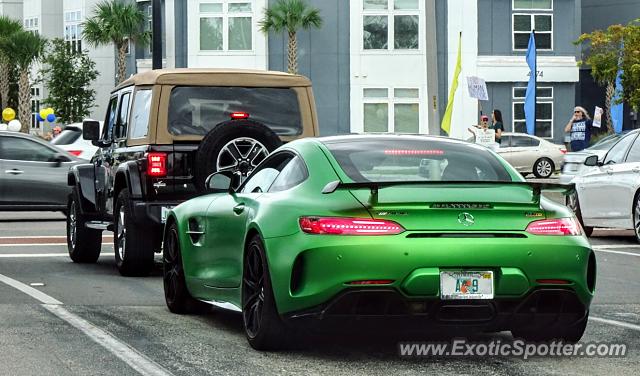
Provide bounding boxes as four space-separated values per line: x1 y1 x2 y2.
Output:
322 180 575 204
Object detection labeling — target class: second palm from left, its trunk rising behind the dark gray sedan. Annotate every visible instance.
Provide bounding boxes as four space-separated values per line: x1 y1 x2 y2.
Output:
0 30 47 133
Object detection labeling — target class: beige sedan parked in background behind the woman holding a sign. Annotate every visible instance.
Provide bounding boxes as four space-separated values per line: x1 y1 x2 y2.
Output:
497 132 567 178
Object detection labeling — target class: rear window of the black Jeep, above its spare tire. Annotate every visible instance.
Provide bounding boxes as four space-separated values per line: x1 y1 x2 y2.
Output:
169 86 302 136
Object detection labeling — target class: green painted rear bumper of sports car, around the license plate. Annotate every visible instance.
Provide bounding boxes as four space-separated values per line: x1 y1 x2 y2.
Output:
264 232 596 316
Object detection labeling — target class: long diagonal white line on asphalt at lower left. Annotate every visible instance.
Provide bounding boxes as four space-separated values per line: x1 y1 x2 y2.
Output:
0 274 172 376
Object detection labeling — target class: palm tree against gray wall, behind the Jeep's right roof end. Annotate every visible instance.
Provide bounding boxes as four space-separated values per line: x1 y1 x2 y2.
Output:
260 0 322 74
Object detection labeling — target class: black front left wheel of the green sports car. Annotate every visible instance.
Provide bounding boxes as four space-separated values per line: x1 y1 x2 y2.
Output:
162 222 211 314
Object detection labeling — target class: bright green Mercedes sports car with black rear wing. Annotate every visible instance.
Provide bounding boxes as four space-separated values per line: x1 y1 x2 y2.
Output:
163 135 596 350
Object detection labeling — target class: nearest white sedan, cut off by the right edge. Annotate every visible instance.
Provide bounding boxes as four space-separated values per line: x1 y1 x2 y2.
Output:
567 130 640 238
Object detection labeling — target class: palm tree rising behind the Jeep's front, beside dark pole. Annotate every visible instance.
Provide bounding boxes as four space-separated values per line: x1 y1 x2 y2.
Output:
82 0 150 83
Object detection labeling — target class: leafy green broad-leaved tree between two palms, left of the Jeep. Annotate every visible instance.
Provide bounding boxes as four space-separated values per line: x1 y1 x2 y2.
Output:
40 39 98 123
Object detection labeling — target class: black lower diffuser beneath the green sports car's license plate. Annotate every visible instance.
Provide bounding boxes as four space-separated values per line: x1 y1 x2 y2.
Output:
284 288 588 332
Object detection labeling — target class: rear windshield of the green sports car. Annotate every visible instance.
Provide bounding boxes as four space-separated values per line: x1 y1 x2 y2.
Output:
325 138 512 182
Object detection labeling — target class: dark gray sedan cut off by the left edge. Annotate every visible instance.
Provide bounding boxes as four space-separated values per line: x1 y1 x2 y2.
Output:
0 131 81 212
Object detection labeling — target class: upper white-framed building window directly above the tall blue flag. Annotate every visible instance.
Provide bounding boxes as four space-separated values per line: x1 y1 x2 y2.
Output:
511 0 553 51
